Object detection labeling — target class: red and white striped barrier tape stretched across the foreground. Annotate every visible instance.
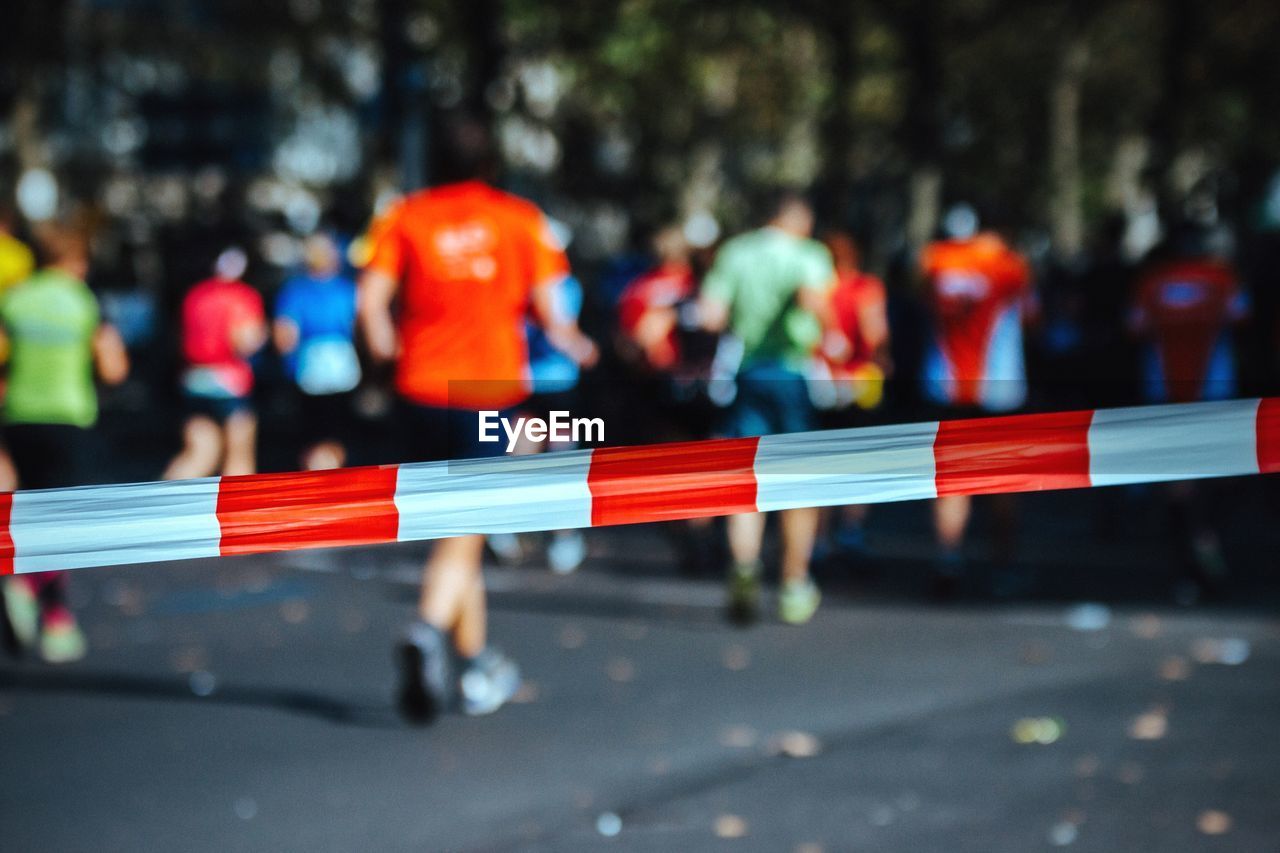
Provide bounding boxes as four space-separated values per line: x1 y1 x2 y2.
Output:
0 398 1280 574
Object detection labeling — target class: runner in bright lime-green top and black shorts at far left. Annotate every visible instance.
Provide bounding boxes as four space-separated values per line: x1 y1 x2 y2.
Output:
0 227 129 663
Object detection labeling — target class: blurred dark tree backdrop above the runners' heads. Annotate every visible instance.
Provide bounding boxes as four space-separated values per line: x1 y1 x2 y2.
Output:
0 0 1280 281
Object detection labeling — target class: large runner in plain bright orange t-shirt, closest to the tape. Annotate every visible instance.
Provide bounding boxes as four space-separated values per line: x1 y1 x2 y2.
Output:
357 112 596 722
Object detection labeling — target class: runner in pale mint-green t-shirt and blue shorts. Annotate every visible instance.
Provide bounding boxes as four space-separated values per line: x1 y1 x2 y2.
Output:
699 193 836 625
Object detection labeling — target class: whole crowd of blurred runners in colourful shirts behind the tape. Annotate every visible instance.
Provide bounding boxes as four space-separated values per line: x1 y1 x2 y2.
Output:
0 112 1264 721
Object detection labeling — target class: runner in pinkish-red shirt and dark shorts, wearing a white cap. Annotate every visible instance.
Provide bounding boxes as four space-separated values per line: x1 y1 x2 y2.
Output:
164 248 268 480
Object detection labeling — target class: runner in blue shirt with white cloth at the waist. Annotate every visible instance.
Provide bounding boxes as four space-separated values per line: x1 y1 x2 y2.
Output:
273 234 360 470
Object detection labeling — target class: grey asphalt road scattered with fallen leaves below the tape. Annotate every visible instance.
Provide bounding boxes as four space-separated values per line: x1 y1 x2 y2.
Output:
0 487 1280 853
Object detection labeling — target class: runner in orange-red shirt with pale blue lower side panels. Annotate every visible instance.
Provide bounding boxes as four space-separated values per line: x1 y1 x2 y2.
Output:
920 205 1034 597
